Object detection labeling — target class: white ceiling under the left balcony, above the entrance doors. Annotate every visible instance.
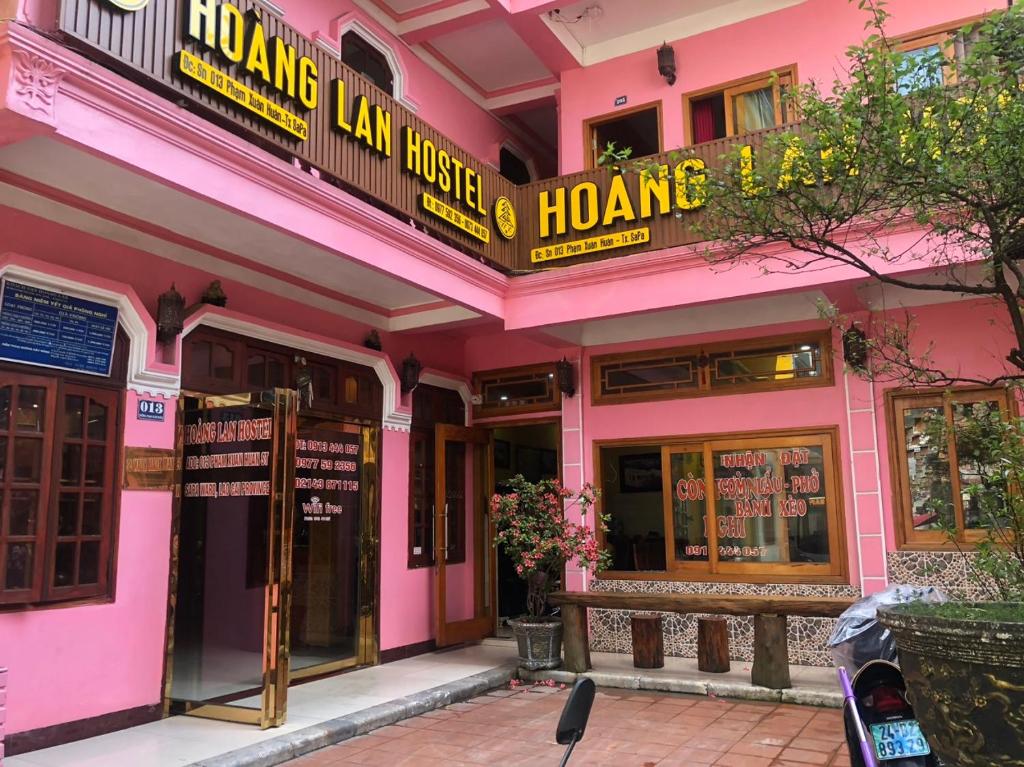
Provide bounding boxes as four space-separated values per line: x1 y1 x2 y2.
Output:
0 137 476 327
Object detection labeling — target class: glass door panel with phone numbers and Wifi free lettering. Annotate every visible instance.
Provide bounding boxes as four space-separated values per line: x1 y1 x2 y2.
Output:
290 416 376 678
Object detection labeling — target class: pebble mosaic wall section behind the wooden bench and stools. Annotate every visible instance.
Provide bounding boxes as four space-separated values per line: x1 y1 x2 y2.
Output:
590 579 860 666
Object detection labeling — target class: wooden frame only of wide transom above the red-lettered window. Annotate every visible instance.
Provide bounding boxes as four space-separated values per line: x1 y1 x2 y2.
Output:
590 331 835 406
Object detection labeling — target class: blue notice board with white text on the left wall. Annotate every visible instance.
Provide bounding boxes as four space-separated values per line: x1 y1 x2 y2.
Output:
0 280 118 376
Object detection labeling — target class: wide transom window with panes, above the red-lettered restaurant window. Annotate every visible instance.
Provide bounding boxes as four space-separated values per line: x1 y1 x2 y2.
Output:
591 333 831 404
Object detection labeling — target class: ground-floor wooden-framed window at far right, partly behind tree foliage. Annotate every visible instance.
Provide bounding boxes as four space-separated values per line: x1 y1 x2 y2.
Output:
889 389 1010 547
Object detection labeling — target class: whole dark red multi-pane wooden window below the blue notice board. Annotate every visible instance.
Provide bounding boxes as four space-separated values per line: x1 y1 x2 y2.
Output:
0 370 121 604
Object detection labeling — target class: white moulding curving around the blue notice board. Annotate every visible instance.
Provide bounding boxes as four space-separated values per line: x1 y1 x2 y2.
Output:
0 260 181 397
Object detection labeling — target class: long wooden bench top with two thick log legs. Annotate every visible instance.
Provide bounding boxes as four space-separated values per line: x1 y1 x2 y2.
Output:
549 591 854 690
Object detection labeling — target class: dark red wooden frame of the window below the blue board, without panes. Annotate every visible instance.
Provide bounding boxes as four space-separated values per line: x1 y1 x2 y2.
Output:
0 368 127 610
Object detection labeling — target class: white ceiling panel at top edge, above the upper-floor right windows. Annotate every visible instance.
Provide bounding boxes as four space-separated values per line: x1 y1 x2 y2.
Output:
541 0 806 66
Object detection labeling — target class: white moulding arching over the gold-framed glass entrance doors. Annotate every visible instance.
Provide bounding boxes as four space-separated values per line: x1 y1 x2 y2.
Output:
181 306 413 431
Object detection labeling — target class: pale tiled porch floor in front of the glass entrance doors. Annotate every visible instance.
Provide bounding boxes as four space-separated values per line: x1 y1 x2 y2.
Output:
3 645 515 767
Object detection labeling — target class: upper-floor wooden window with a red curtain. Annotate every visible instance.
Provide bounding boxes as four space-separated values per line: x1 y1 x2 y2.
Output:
683 68 797 143
